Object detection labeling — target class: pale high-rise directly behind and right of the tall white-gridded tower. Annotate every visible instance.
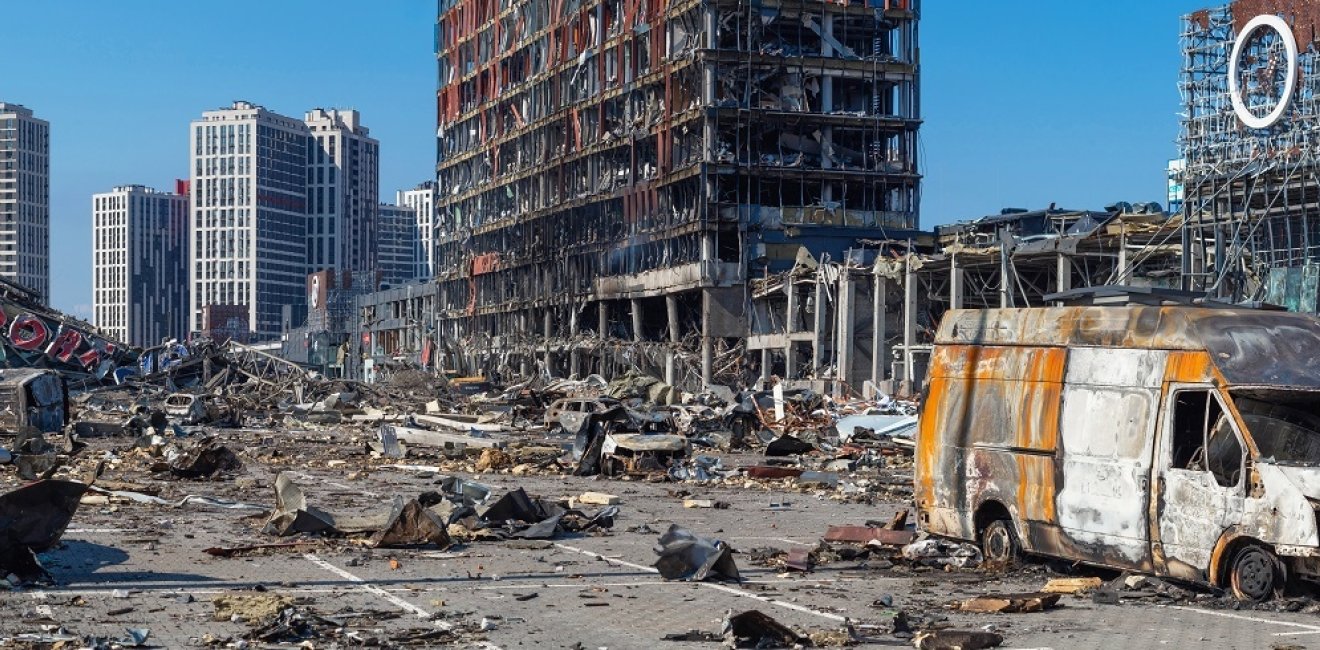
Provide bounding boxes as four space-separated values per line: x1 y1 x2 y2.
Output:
304 108 380 273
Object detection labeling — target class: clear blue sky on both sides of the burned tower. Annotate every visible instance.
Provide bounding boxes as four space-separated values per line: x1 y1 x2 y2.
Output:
0 0 1206 317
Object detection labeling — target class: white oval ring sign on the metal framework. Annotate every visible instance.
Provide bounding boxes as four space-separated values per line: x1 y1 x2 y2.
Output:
1229 16 1298 128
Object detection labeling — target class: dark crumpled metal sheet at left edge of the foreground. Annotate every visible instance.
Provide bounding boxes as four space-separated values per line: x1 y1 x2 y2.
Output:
0 480 87 583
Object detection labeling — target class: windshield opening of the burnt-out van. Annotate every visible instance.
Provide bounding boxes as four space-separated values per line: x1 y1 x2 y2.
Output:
1233 390 1320 465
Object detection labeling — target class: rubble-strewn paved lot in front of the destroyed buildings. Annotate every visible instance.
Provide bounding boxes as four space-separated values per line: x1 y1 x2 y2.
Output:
0 293 1320 647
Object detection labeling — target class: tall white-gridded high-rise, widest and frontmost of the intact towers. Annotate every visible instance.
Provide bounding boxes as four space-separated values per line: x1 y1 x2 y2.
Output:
189 102 310 338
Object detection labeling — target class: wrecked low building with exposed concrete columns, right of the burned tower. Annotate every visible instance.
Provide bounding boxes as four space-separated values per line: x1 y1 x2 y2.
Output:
747 203 1181 395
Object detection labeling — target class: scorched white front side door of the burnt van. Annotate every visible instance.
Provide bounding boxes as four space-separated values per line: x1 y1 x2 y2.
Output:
1151 384 1246 580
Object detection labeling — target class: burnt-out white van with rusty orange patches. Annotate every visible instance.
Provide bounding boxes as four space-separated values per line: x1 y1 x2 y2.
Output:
915 307 1320 600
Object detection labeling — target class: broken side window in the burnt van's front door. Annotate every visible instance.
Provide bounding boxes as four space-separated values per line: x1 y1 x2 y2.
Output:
1170 390 1243 488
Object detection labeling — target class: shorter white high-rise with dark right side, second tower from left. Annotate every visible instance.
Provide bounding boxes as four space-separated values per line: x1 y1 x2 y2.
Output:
91 181 189 347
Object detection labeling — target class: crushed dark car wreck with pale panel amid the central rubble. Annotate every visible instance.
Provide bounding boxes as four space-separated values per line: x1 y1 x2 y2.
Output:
573 403 690 476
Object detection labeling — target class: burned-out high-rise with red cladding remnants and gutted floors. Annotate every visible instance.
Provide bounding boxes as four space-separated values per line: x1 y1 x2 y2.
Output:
436 0 920 384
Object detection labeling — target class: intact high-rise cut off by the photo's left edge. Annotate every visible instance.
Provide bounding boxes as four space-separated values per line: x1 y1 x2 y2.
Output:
0 102 50 301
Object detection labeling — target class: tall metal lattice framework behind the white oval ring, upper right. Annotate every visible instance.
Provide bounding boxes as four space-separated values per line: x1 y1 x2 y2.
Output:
1179 0 1320 304
